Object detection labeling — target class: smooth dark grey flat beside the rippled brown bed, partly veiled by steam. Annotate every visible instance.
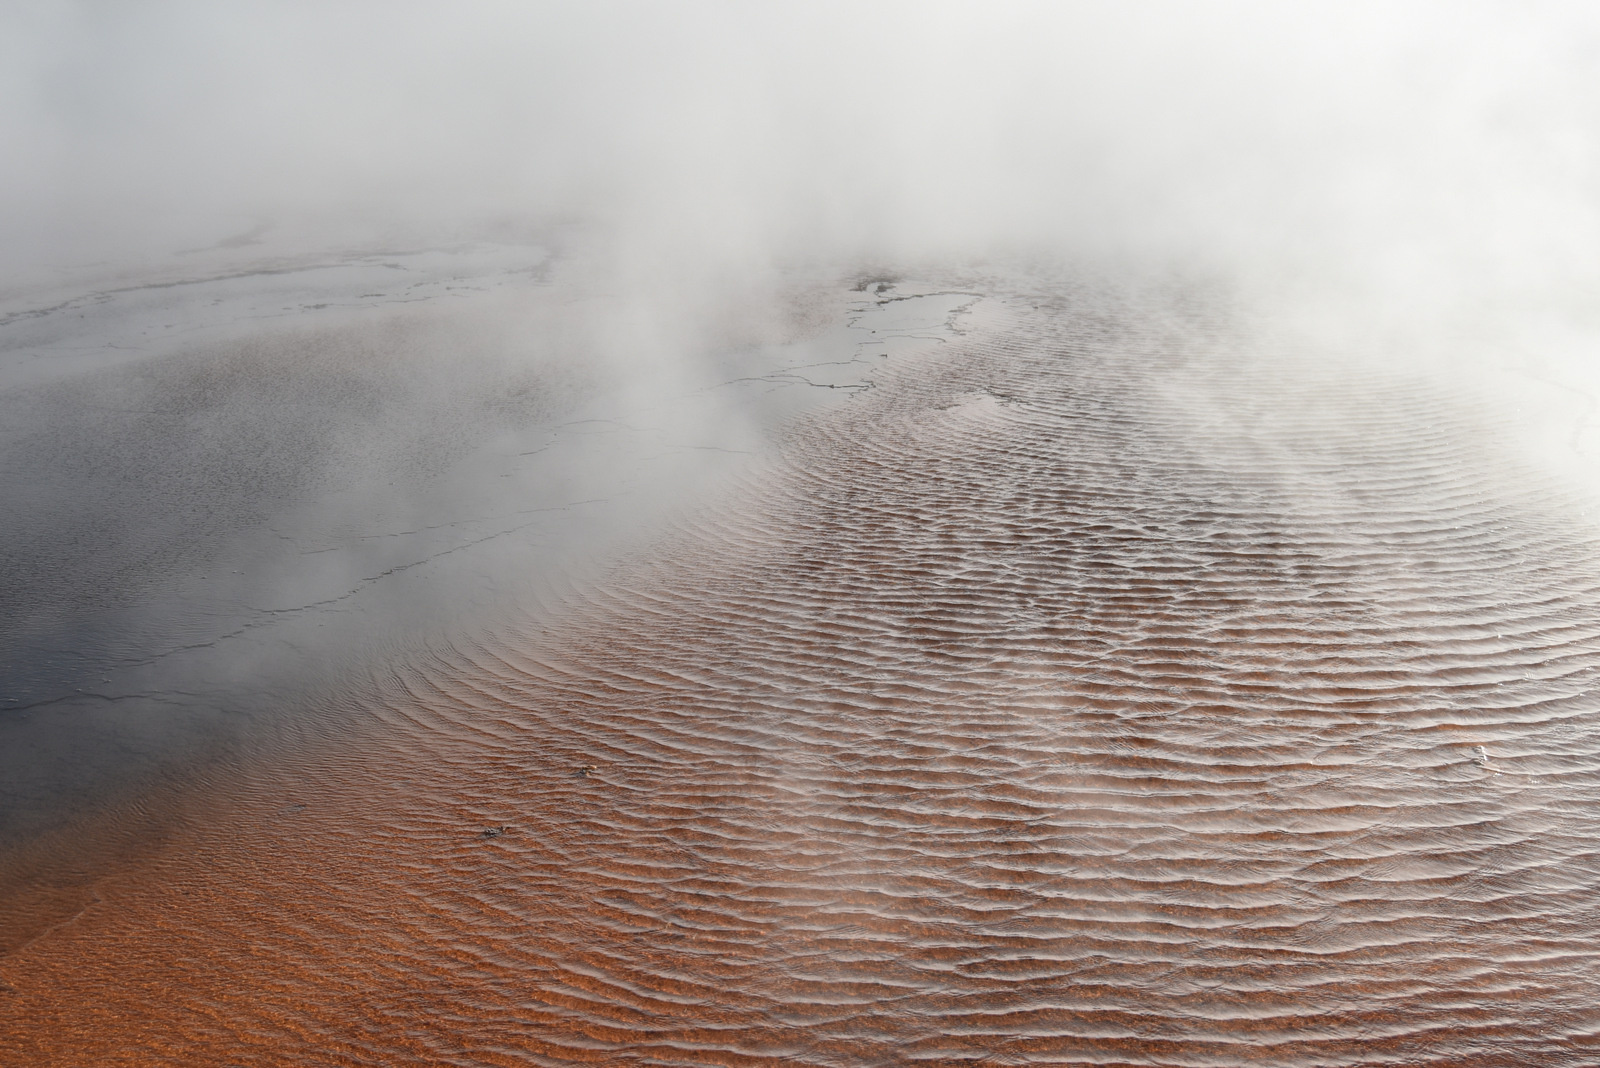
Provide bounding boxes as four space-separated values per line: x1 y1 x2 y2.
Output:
0 245 940 951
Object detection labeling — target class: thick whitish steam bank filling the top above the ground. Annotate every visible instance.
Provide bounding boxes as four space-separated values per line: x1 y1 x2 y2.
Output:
0 0 1600 304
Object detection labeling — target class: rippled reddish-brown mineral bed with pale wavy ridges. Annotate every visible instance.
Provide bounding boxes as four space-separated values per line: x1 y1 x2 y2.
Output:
0 279 1600 1065
